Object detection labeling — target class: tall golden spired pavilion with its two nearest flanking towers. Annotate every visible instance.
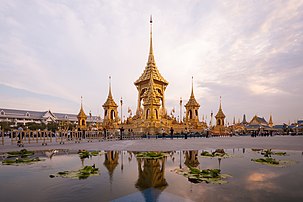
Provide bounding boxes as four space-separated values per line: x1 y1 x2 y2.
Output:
78 18 211 135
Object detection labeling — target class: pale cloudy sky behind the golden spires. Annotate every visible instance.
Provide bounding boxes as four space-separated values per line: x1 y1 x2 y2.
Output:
0 0 303 124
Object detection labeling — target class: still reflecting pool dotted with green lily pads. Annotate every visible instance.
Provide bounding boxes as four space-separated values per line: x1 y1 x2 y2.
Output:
0 148 303 201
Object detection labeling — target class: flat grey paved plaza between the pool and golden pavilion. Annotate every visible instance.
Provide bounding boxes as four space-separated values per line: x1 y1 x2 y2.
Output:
0 136 303 153
